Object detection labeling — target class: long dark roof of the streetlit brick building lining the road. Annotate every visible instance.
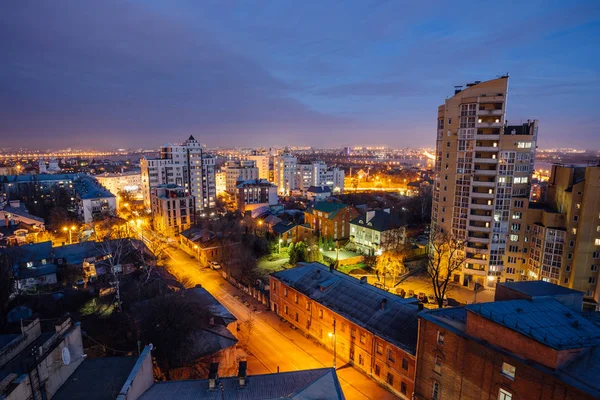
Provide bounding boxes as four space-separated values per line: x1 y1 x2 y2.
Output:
272 262 418 354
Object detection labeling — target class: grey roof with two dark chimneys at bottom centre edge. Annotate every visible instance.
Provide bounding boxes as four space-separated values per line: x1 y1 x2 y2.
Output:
140 368 345 400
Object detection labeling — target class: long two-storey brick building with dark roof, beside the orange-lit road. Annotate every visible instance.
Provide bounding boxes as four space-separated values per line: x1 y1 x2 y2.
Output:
270 263 419 399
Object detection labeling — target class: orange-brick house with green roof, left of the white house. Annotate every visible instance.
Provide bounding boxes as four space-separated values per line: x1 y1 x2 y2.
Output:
304 201 359 241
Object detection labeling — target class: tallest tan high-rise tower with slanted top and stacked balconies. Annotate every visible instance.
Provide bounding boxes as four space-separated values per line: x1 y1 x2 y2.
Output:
432 76 538 287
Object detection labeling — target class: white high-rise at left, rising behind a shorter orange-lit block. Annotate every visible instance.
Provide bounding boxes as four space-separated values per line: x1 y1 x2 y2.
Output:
140 136 217 211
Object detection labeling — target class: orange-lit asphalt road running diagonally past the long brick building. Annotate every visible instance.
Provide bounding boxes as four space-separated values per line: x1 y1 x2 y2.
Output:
162 245 398 399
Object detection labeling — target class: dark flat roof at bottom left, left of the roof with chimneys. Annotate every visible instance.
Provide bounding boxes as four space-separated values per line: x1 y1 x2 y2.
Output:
52 357 137 400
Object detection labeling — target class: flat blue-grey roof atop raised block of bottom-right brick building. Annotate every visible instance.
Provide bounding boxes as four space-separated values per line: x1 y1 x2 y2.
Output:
466 298 600 350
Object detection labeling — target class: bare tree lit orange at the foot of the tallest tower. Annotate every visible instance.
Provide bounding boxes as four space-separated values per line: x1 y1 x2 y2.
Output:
425 230 465 308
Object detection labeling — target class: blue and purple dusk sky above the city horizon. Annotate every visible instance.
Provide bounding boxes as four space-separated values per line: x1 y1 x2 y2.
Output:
0 1 600 148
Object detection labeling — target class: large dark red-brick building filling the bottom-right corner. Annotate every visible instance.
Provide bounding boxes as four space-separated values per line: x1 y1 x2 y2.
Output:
415 281 600 400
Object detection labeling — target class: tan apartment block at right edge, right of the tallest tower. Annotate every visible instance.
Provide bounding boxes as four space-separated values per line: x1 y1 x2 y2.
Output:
506 163 600 307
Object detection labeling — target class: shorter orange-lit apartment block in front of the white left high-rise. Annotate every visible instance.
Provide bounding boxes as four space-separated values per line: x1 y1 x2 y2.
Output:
150 184 196 237
